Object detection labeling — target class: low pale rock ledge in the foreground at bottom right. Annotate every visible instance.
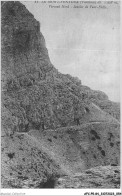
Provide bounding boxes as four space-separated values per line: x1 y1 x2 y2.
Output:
55 166 120 189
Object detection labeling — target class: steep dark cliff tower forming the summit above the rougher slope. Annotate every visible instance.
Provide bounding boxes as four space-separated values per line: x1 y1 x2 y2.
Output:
2 1 52 85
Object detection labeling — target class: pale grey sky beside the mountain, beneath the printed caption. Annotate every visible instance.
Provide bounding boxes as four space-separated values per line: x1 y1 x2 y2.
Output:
22 1 120 101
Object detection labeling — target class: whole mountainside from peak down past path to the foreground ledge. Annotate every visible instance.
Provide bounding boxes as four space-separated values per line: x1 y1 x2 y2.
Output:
1 1 120 188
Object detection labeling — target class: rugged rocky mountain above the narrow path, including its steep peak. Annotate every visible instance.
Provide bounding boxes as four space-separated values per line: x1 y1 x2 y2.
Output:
2 1 120 134
